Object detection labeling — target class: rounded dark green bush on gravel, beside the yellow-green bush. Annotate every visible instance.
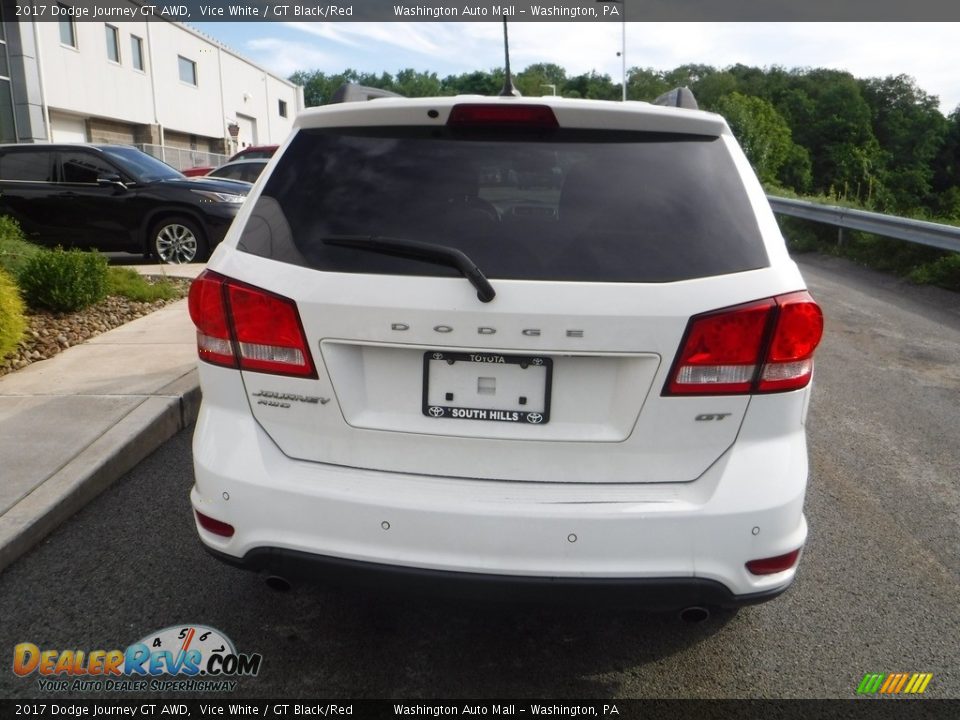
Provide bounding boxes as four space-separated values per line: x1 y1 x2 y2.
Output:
18 248 107 312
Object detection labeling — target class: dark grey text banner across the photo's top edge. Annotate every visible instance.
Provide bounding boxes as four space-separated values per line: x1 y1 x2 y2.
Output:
13 0 960 21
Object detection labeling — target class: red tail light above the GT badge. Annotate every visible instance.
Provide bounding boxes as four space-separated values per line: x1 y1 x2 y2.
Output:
664 291 823 395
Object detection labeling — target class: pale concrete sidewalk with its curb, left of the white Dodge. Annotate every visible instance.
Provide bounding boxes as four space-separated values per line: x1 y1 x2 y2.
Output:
0 265 203 571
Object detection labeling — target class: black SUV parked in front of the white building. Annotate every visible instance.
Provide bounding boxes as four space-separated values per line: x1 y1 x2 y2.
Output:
0 144 250 263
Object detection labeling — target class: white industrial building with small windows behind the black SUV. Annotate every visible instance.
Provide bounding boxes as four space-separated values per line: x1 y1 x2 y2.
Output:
0 0 303 169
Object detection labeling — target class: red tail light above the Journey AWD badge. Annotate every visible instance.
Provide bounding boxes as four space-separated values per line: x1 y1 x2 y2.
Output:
188 270 317 378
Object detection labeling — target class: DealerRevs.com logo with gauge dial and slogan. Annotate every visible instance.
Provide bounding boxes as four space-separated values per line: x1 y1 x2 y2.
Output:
13 625 263 692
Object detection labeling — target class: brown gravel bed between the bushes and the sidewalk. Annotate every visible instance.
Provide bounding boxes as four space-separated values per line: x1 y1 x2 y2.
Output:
0 278 190 376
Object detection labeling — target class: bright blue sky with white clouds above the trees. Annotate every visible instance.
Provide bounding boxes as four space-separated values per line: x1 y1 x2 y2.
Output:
193 22 960 114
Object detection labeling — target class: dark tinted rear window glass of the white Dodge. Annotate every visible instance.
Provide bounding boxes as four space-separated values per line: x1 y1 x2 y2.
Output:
238 128 768 282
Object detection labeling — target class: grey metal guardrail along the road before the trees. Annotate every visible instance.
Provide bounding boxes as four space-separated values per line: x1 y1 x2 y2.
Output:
767 195 960 252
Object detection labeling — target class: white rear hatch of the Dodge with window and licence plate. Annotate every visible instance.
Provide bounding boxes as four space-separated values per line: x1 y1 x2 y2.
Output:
216 99 794 483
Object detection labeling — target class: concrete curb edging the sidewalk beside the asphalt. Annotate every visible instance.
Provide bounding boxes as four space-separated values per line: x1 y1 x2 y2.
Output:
0 376 200 572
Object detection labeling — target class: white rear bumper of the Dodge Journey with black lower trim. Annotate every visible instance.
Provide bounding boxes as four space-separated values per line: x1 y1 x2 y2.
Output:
191 371 807 607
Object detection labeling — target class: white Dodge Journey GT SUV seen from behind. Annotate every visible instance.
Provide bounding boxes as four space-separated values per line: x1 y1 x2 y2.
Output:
190 97 823 608
